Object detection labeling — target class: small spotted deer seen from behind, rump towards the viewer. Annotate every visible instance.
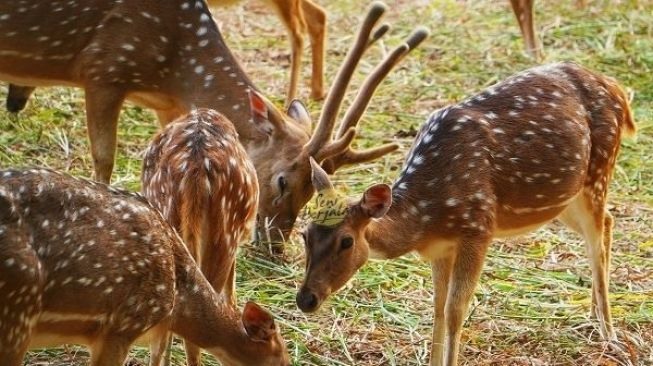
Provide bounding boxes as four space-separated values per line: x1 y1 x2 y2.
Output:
141 109 258 365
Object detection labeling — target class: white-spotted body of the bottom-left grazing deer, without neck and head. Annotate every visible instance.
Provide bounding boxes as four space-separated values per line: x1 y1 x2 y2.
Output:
0 170 181 349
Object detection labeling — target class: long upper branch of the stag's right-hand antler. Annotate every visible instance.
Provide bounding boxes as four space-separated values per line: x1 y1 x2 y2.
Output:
337 27 429 136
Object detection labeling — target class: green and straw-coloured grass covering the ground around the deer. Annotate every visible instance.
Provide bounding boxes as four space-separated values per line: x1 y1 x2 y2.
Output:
5 0 653 365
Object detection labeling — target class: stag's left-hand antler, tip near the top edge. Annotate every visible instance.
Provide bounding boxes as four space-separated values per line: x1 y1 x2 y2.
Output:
306 2 386 155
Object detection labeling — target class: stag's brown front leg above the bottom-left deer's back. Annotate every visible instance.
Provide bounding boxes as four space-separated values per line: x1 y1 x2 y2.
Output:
86 87 124 183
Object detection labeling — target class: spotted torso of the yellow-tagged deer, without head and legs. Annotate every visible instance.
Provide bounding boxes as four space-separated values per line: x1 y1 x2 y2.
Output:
394 63 634 240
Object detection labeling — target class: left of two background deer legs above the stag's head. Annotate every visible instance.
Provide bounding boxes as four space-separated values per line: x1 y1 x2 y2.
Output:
277 2 305 106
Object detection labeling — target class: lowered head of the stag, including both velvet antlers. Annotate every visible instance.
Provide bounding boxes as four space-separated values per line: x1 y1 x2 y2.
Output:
248 3 428 250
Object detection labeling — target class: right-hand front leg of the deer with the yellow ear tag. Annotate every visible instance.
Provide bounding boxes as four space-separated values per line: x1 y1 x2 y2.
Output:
444 236 491 366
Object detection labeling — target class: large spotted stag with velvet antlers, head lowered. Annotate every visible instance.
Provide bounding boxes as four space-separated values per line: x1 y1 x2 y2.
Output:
0 0 426 250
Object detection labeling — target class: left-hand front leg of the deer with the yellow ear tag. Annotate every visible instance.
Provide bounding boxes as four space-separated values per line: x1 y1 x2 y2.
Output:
431 257 455 366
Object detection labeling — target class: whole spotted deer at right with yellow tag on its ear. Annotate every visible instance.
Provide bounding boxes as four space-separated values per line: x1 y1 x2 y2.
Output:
297 63 635 365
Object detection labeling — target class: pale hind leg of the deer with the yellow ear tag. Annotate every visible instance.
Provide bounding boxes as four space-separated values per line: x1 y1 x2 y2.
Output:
560 190 615 339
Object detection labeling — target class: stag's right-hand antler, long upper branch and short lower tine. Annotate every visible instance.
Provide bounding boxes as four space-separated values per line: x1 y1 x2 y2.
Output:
324 27 429 173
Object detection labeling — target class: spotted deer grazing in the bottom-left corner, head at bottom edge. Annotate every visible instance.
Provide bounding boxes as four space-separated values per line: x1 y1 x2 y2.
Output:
0 169 289 366
